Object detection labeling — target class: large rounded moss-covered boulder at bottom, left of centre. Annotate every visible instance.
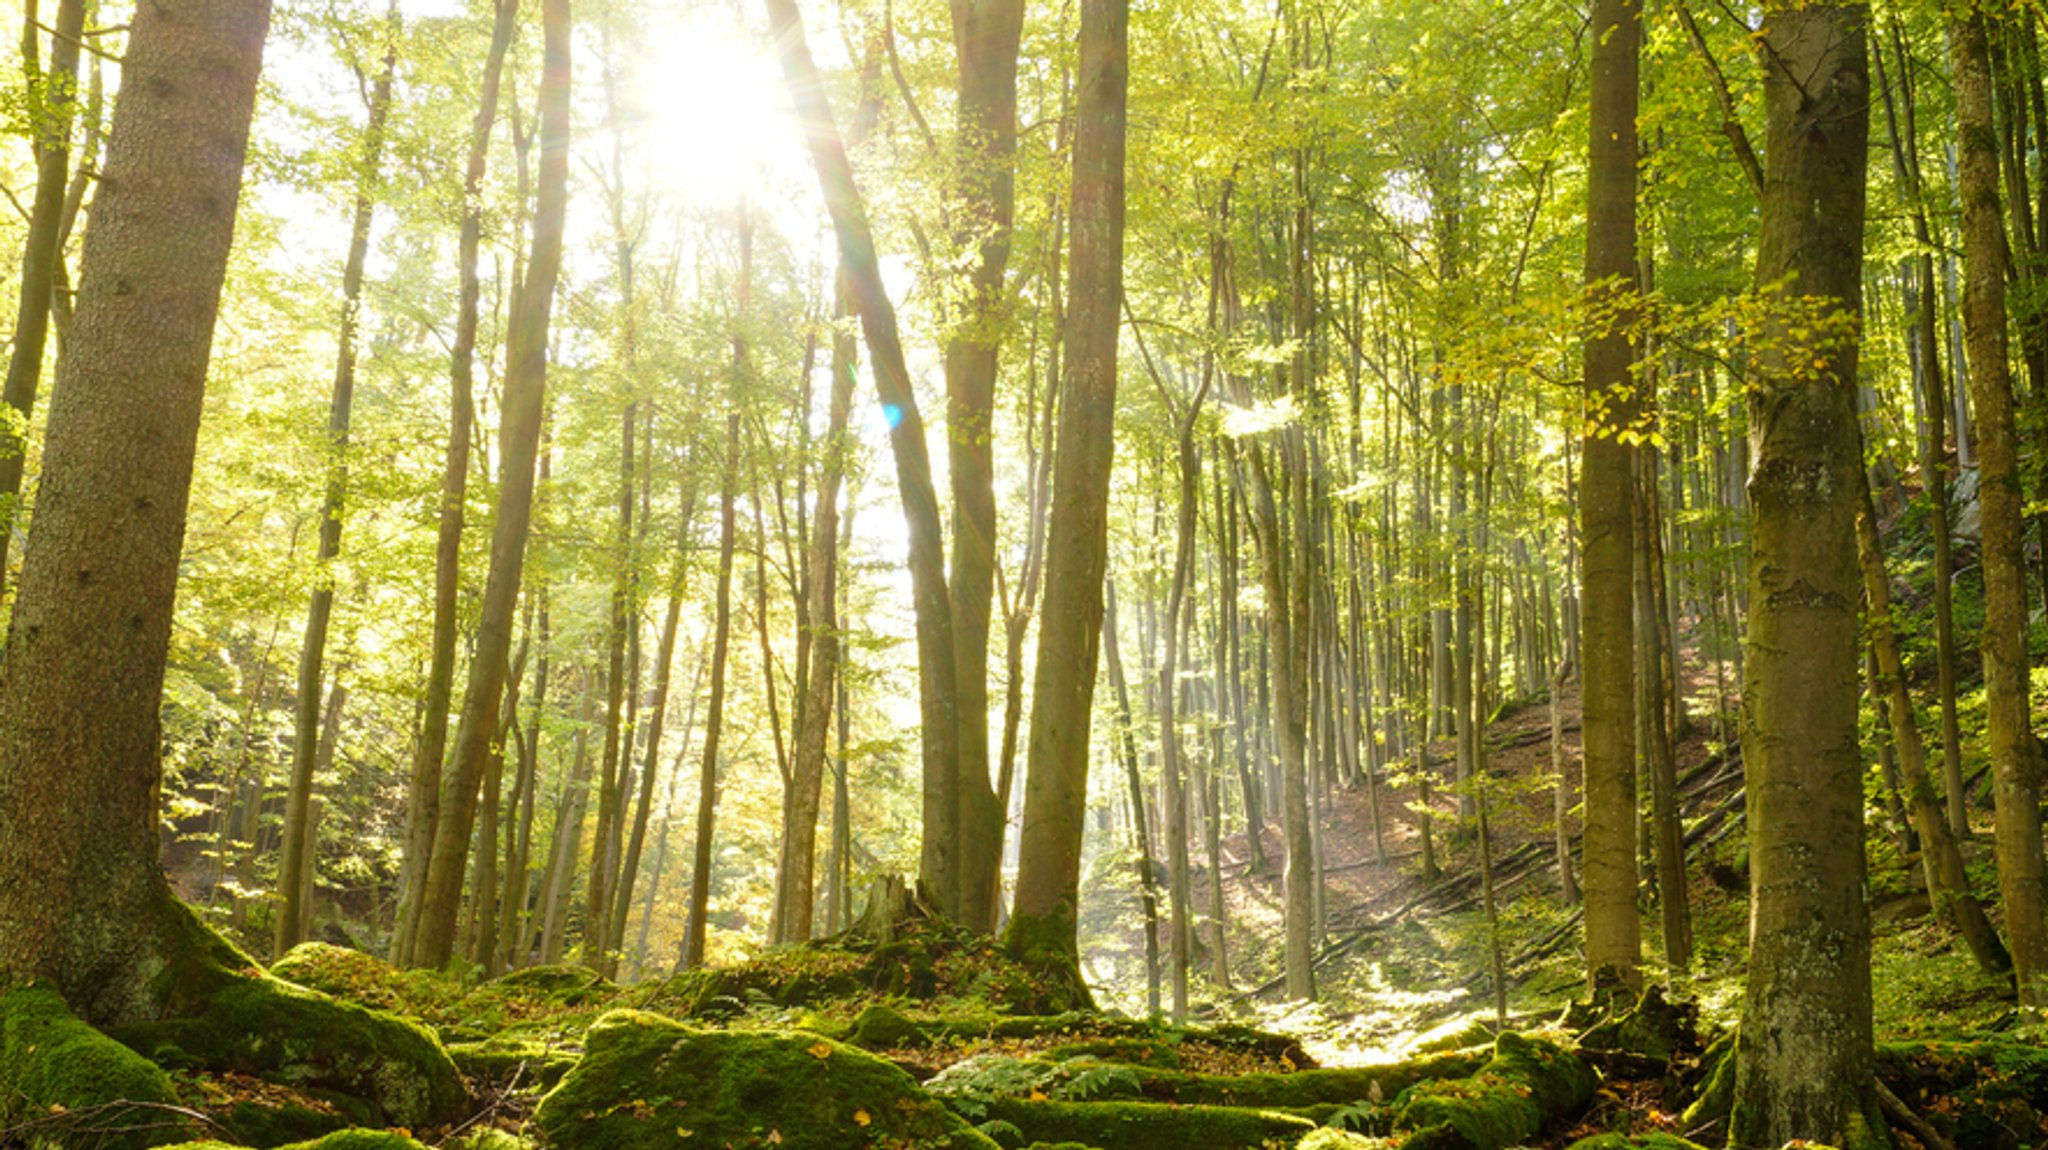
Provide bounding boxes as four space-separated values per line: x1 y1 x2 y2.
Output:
535 1011 995 1150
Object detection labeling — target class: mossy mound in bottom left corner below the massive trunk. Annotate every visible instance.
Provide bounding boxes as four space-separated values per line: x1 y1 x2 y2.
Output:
0 984 190 1150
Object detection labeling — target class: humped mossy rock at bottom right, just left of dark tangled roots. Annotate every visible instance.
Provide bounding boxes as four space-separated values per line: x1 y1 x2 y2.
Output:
1395 1033 1593 1150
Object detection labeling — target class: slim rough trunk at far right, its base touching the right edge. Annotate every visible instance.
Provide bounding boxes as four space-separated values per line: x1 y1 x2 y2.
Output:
1948 12 2048 1007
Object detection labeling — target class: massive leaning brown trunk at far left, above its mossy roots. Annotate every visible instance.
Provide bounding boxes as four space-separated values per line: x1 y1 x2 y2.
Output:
0 0 270 1010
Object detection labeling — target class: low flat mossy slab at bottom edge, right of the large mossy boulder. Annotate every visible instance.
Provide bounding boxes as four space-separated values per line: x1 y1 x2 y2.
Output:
985 1099 1315 1150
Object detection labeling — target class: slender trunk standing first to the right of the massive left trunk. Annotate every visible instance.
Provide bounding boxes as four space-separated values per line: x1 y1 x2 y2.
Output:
270 26 399 954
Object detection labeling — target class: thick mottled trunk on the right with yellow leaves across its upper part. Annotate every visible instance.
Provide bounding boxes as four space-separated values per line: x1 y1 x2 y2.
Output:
1729 2 1890 1150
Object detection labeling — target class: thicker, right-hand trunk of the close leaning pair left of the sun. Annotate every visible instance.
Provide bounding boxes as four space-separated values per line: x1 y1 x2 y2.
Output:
412 0 571 966
